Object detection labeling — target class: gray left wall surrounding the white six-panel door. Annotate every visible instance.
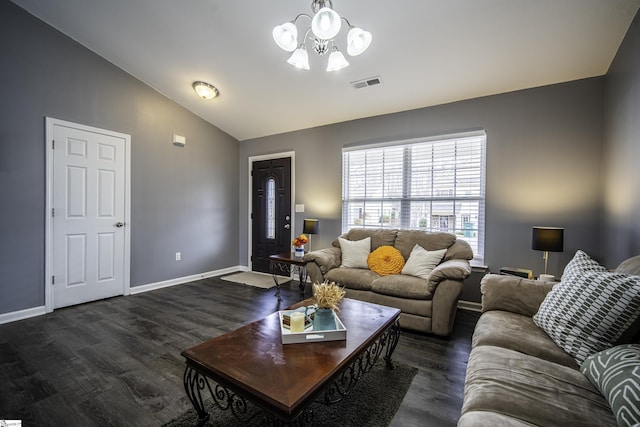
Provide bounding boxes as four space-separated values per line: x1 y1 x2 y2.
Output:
0 1 238 313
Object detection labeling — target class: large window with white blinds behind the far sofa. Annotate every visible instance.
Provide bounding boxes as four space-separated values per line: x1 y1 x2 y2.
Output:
342 132 486 262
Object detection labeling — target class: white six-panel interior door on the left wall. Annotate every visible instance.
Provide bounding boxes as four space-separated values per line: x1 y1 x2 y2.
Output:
48 121 128 308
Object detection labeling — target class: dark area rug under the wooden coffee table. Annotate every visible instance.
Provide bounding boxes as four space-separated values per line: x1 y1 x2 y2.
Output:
163 361 418 427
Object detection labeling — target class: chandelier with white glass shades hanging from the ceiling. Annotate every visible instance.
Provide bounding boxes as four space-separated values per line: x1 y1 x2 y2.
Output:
273 0 371 71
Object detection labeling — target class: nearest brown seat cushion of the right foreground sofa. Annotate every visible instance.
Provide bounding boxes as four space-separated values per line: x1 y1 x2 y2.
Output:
462 346 616 427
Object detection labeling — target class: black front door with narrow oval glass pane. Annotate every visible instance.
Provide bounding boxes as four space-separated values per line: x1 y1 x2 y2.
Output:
251 157 292 273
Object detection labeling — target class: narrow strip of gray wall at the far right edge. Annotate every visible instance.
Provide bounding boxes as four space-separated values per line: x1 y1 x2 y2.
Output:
603 12 640 266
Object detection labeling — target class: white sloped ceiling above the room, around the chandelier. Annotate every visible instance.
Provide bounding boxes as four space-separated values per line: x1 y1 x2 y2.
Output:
13 0 640 141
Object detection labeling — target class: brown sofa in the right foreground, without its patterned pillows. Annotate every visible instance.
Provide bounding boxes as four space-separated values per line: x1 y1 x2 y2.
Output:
458 257 640 427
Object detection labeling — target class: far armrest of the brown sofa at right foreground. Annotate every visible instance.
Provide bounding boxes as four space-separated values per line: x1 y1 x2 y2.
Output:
480 274 554 317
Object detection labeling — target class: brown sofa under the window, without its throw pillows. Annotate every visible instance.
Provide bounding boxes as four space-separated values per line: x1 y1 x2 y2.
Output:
304 228 473 336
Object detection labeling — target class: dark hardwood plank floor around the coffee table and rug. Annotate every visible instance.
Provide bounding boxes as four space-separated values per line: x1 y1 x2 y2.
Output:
0 278 478 427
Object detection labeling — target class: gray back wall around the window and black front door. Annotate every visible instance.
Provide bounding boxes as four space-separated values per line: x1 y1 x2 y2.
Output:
238 77 604 275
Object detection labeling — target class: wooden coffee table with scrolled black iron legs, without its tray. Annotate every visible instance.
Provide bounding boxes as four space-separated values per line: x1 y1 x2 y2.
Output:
182 298 400 425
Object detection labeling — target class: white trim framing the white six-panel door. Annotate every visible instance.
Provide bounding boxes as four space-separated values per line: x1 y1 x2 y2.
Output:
44 117 131 313
